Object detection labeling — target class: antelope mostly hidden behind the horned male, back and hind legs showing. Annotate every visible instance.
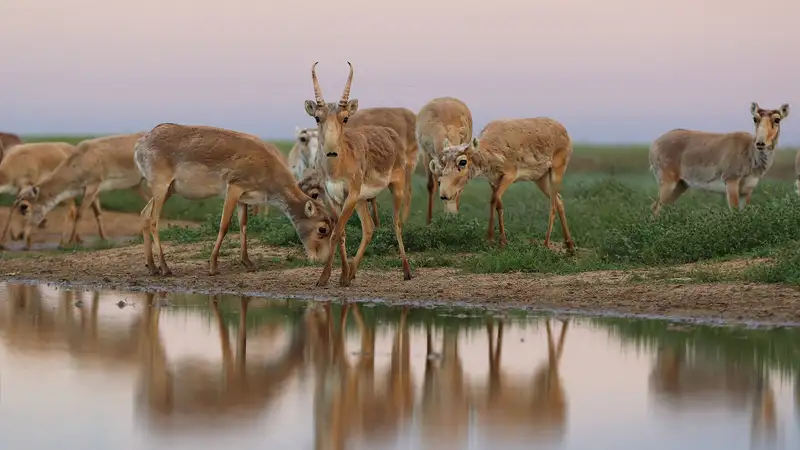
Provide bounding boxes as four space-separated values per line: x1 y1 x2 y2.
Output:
345 107 419 227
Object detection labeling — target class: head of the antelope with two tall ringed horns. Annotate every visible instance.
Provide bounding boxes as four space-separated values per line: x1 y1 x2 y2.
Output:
305 61 358 161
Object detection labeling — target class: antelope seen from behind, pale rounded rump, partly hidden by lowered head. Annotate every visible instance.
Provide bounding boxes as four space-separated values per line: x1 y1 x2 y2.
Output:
415 97 472 224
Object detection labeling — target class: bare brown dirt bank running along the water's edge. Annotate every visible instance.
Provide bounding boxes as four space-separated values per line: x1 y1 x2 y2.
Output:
0 238 800 322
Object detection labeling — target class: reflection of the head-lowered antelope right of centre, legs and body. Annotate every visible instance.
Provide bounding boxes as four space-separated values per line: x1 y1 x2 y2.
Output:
477 318 569 441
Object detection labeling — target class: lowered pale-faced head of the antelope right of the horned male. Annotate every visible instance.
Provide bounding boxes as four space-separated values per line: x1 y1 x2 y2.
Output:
430 137 480 212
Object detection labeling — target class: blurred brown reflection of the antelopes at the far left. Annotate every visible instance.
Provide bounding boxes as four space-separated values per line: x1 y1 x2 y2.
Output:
0 284 152 367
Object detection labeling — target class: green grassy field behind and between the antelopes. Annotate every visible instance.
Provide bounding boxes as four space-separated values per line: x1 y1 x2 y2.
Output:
2 137 800 284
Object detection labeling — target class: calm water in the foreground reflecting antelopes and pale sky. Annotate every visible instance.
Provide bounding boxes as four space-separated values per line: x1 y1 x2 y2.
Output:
0 284 800 450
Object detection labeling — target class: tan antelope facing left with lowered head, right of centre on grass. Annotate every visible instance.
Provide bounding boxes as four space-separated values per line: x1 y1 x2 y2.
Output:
430 117 575 252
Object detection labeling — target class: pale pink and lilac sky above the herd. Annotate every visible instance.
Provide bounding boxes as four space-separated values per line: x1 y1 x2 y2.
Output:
0 0 800 145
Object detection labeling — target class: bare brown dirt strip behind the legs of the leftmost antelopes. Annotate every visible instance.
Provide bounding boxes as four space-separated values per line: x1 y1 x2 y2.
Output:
0 206 195 250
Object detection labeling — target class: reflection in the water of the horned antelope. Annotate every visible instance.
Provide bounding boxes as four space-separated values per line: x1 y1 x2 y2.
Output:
314 303 414 450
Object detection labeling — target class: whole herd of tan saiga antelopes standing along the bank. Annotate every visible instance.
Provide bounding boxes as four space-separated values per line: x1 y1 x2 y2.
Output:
0 62 800 286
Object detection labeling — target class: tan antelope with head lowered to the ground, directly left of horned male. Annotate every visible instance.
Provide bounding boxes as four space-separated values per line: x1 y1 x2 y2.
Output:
134 123 334 275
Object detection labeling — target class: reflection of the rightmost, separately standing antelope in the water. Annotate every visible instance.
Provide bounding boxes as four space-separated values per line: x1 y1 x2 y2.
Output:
650 345 777 440
